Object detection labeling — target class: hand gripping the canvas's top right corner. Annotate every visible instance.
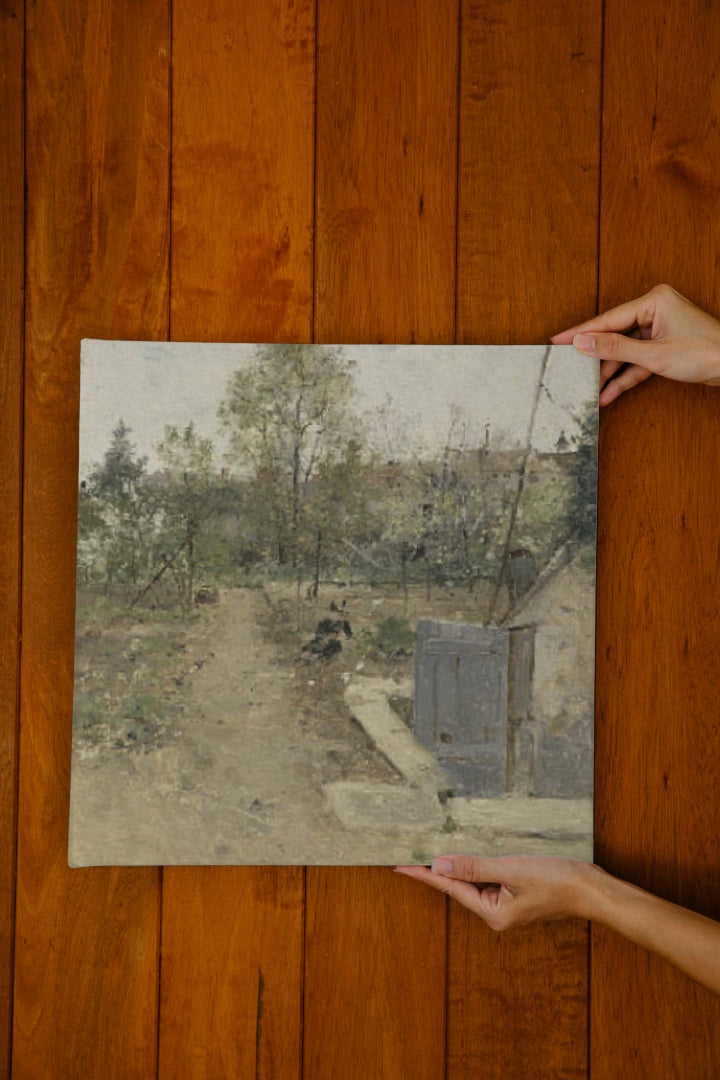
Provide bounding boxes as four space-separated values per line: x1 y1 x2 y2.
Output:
551 285 720 405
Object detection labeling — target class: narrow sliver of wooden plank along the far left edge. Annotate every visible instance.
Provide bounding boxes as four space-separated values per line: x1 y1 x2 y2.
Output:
0 0 25 1075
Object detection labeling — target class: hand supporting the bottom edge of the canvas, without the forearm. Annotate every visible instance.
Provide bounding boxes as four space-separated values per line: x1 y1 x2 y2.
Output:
395 855 604 930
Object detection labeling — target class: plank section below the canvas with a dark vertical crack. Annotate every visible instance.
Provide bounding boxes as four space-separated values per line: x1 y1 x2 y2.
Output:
160 866 302 1080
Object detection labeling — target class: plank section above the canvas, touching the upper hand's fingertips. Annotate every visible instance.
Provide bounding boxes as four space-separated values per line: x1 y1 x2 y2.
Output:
458 0 602 345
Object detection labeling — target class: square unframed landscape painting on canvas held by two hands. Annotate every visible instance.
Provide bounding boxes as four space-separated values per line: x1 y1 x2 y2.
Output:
69 340 597 866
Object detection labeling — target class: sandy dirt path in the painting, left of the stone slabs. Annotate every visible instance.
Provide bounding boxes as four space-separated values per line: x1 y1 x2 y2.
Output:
70 590 414 865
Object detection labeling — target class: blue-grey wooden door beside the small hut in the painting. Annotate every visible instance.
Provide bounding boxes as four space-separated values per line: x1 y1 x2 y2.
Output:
415 619 510 796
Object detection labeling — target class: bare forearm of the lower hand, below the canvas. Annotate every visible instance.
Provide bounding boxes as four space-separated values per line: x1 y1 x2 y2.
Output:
582 867 720 994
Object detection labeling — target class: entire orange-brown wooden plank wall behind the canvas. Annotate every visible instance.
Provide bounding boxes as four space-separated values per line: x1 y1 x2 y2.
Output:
0 0 720 1080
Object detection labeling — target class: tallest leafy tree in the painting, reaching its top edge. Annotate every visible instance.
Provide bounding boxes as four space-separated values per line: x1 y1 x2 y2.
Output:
220 345 359 577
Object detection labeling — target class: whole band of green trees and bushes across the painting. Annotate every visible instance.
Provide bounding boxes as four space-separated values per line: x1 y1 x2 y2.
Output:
78 369 597 616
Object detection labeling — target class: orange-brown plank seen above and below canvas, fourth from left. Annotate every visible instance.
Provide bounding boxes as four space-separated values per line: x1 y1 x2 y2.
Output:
304 0 458 1080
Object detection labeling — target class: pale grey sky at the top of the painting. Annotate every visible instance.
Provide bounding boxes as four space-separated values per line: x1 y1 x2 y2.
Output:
80 339 598 477
